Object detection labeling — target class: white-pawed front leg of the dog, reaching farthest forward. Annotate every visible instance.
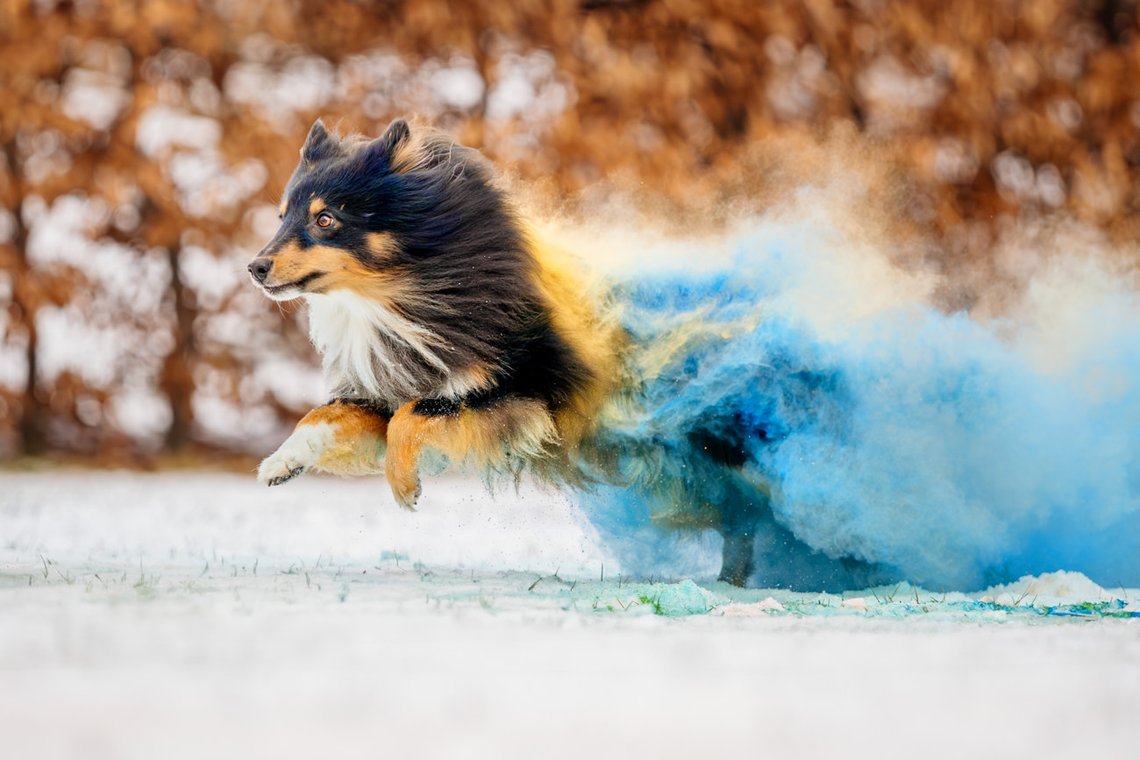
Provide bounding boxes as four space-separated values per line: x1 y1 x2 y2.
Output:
258 399 389 485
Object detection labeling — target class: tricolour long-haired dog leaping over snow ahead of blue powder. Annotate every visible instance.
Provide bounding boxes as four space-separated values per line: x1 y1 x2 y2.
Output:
249 120 766 583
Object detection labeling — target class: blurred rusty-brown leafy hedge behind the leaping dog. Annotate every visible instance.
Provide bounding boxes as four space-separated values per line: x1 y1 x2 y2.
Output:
0 0 1140 464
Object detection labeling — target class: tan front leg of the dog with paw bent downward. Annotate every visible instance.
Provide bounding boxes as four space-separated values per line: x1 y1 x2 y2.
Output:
384 398 557 509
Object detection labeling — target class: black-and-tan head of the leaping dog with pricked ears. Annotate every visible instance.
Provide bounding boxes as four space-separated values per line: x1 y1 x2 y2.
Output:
249 119 513 301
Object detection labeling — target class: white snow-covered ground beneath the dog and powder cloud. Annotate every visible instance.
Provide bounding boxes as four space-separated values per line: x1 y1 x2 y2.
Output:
0 472 1140 759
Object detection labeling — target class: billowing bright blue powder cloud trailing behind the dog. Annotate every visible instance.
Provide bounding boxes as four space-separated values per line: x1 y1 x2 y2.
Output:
584 216 1140 590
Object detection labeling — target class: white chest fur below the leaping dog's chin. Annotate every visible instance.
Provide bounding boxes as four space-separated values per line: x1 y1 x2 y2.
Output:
306 291 450 406
